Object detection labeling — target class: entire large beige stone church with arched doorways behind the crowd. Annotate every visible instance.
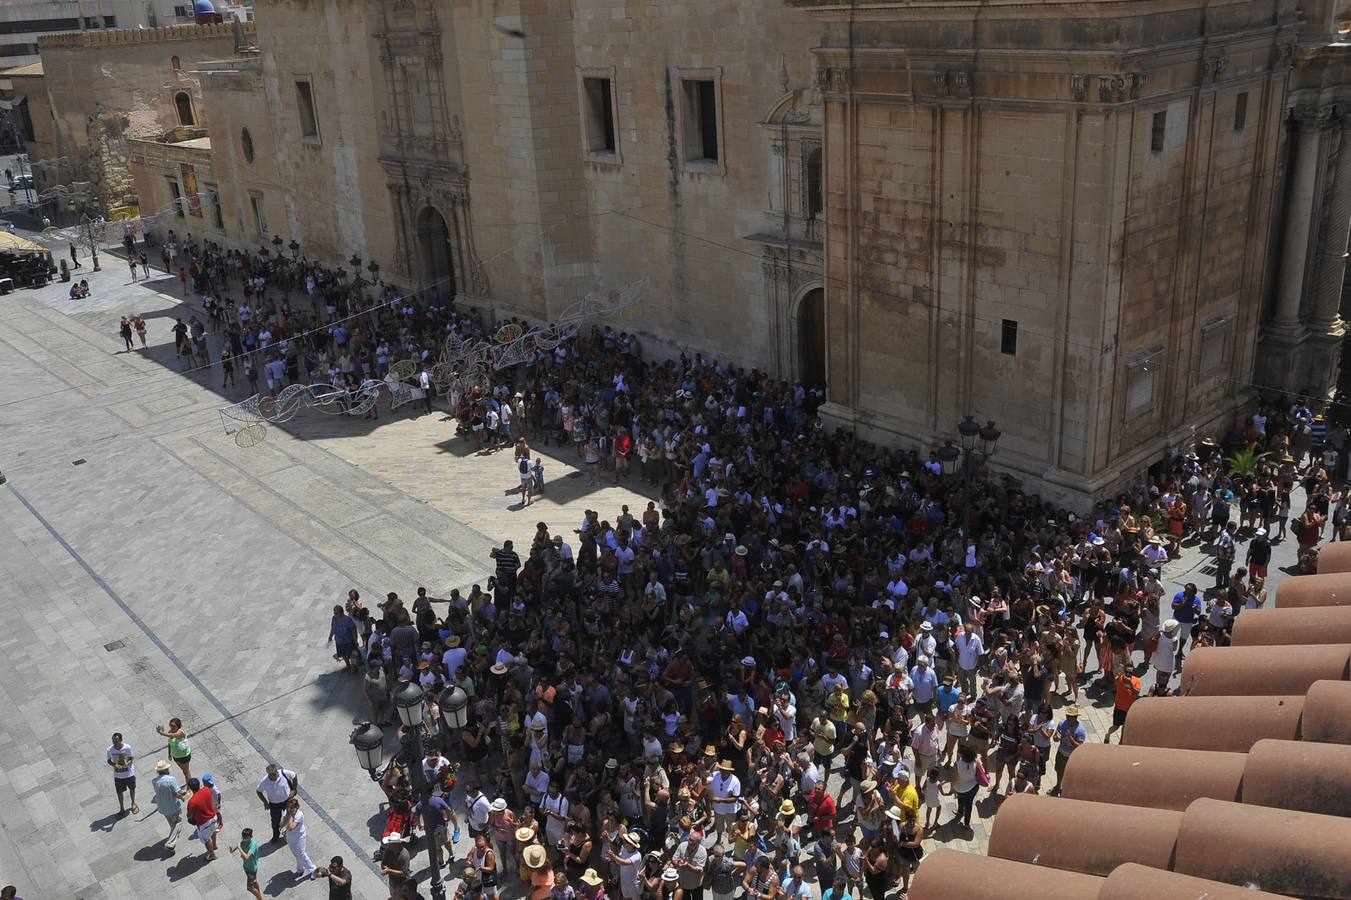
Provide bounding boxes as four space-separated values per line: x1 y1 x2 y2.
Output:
116 0 1351 503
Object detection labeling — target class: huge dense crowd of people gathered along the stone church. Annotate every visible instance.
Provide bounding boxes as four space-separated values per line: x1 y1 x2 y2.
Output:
97 232 1351 900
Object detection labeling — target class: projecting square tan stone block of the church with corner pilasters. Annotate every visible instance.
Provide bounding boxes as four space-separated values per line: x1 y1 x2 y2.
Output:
817 1 1296 503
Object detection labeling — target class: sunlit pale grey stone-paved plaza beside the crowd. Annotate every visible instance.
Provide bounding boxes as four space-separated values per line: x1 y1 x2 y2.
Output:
0 245 1294 900
